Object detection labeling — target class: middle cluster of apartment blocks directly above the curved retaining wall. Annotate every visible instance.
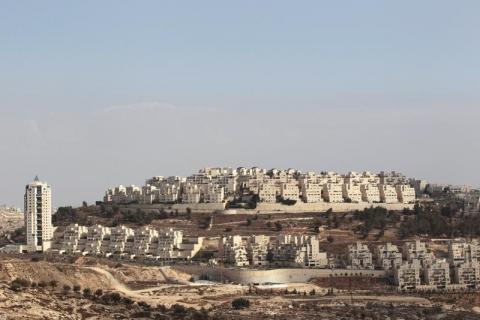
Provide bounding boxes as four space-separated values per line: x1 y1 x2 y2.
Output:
220 234 328 268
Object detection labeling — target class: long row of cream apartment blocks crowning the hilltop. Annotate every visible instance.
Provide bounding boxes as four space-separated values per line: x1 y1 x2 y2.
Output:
104 167 418 204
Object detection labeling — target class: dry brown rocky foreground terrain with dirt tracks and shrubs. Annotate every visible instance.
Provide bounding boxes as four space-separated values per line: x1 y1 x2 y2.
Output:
0 255 480 320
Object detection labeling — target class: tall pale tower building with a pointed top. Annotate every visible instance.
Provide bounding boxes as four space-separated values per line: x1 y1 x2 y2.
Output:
25 177 53 252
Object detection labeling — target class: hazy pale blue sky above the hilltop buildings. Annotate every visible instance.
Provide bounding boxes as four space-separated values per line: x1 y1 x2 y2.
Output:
0 0 480 207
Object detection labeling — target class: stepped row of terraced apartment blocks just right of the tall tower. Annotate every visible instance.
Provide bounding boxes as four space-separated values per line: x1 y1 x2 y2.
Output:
60 224 203 261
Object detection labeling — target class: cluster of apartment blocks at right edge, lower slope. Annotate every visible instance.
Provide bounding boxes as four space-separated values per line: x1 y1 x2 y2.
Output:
346 239 480 290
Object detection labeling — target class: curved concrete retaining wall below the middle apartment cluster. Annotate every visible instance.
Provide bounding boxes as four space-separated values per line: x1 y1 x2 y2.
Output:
173 265 386 284
